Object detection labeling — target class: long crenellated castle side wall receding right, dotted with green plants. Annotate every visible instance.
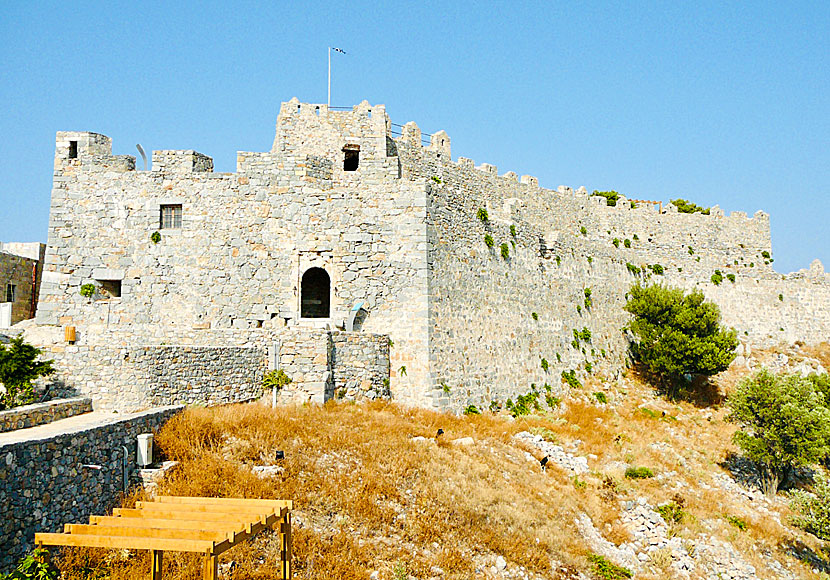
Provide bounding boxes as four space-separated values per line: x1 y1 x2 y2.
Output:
397 136 830 409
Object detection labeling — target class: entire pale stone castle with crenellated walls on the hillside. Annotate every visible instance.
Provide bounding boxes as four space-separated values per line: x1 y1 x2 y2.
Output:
22 99 830 410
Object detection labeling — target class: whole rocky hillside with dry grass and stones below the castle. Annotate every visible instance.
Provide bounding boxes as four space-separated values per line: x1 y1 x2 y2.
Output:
59 347 830 580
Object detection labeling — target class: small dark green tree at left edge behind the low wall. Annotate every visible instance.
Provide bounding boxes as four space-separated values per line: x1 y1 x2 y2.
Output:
0 336 55 410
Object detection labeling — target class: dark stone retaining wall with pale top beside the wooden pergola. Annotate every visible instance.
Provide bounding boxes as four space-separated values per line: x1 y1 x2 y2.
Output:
0 407 181 571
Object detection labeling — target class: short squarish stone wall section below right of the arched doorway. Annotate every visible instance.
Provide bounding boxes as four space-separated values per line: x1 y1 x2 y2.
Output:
331 332 390 401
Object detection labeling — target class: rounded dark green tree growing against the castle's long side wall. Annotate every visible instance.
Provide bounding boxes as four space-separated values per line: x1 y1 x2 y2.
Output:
624 284 738 396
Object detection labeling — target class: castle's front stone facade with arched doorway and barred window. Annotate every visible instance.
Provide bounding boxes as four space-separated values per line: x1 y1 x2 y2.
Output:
37 105 429 404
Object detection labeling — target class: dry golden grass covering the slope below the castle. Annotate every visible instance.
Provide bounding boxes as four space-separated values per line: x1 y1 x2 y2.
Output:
55 358 830 580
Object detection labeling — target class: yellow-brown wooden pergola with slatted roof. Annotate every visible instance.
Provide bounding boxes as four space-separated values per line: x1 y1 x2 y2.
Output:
35 496 293 580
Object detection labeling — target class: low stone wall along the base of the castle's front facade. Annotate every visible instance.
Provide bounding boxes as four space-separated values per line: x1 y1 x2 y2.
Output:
24 326 389 411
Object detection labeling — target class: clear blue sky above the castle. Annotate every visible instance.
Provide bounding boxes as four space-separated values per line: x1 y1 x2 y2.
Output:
0 0 830 272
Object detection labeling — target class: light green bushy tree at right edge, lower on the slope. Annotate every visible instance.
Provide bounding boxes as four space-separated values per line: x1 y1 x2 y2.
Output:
729 370 830 495
